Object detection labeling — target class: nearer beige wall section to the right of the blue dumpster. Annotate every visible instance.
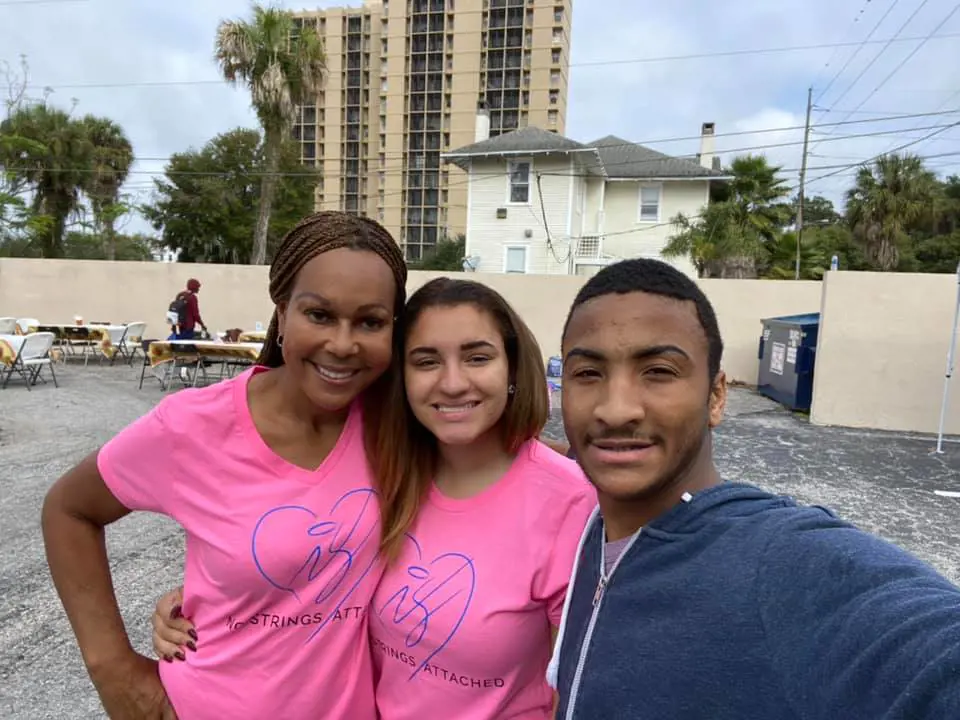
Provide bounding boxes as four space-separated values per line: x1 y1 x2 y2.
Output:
811 272 960 434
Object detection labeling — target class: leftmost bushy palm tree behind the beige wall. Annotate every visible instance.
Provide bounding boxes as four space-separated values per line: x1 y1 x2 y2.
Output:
0 103 92 257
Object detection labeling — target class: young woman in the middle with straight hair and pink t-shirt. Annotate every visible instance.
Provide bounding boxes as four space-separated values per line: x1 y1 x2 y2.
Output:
154 278 596 720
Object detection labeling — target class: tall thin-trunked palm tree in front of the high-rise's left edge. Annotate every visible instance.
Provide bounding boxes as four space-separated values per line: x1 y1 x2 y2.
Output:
216 4 326 265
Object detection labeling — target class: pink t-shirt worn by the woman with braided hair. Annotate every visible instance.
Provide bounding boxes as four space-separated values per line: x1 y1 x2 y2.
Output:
97 368 383 720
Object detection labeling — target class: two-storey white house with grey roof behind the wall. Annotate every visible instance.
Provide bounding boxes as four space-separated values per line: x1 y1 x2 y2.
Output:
444 115 727 276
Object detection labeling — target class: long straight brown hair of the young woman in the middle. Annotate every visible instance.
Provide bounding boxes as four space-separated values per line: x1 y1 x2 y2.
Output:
368 277 549 561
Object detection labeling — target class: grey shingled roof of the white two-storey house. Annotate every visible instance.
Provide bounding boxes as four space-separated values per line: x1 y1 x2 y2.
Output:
443 126 728 180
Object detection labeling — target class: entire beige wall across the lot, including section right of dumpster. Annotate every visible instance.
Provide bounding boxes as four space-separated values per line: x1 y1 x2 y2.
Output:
11 258 960 434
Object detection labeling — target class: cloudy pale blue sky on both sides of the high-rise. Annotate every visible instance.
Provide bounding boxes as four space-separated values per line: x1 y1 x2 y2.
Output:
0 0 960 233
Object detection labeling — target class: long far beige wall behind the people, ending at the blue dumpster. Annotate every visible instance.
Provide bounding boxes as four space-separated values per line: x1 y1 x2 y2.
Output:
0 258 820 384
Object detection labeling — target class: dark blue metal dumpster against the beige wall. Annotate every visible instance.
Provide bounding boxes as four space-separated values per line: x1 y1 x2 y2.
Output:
757 313 820 412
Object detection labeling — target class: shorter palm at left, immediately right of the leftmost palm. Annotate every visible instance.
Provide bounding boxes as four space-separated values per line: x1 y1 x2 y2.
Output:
83 115 133 260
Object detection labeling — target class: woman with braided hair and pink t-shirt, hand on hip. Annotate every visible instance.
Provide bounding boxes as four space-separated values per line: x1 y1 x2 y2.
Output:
42 212 406 720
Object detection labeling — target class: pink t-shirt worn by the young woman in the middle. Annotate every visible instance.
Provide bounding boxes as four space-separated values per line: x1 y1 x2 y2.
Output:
370 441 597 720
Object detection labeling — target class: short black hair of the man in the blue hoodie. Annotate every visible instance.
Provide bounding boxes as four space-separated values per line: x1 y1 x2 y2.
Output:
563 258 723 380
